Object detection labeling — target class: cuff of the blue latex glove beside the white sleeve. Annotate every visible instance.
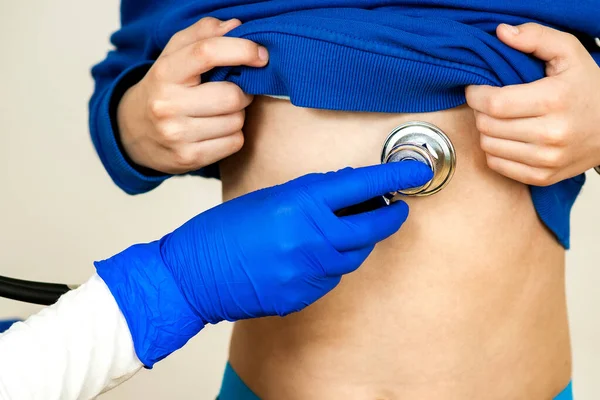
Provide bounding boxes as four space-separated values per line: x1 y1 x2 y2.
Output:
94 242 204 368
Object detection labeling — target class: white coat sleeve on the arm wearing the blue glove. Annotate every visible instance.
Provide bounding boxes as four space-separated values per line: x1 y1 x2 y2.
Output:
0 275 142 400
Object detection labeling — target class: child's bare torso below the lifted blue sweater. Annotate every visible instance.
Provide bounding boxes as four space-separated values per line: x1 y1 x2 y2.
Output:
221 97 571 400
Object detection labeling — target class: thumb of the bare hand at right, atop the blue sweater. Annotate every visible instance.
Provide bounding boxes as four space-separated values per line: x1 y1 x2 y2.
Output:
496 22 581 73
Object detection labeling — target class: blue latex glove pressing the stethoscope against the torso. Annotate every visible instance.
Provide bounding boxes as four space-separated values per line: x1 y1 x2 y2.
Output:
96 161 432 367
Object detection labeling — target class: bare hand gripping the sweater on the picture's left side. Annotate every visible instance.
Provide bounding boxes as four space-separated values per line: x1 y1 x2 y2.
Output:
117 17 268 174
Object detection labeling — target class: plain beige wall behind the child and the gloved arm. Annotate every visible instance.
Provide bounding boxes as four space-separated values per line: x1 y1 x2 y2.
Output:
0 0 600 400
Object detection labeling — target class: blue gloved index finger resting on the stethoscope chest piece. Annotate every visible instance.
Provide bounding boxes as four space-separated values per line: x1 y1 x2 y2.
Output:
312 160 433 211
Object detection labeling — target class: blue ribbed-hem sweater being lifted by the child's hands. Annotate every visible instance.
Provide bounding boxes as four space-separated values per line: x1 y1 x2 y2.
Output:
90 0 600 248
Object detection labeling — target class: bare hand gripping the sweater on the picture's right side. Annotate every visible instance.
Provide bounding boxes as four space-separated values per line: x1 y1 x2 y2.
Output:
466 23 600 186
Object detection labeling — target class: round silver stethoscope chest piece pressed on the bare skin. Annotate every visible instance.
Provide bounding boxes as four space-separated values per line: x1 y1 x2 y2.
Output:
381 121 456 199
